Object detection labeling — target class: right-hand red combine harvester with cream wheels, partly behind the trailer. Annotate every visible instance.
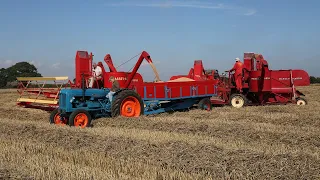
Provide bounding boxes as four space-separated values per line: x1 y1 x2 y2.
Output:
172 53 310 108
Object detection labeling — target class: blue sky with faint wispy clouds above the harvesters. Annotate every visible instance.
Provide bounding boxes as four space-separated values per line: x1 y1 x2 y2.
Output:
0 0 320 80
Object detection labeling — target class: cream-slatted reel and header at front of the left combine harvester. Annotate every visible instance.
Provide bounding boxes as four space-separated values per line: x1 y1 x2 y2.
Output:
17 76 72 110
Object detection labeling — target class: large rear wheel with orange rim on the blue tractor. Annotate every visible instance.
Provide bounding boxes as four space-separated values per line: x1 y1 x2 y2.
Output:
111 90 144 117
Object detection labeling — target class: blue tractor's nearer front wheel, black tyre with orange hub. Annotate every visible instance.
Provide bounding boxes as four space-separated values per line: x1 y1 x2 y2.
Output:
69 109 92 128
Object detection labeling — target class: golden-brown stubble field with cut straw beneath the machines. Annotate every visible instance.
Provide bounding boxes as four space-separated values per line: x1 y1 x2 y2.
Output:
0 85 320 180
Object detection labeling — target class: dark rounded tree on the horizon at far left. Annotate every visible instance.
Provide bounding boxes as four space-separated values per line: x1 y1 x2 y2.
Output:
6 62 42 82
